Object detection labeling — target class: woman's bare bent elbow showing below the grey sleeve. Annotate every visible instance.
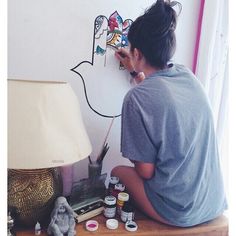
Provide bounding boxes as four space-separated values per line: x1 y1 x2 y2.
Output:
131 160 155 179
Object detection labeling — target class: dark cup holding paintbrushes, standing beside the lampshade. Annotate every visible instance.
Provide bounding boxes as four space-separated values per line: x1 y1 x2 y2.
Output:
88 143 109 178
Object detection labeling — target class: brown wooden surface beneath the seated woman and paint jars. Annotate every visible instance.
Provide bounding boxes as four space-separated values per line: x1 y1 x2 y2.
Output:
16 214 228 236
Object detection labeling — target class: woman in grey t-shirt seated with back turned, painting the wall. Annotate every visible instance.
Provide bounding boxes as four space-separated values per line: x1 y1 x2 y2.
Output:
111 0 226 227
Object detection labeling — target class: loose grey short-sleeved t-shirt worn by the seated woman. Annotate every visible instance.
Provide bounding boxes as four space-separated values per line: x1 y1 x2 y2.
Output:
121 64 227 227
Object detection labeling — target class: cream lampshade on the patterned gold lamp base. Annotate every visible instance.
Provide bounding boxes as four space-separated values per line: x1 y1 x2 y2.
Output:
8 80 91 169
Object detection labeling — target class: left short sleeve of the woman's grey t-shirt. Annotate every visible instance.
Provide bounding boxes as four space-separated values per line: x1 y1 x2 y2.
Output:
121 95 157 163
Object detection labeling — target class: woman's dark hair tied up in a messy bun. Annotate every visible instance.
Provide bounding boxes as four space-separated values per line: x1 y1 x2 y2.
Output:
128 0 179 69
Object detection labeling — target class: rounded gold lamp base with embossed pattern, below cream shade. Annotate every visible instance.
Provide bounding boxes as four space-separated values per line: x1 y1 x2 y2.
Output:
8 168 62 226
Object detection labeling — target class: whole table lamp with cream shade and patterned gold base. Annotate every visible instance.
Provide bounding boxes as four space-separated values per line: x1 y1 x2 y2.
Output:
8 80 91 226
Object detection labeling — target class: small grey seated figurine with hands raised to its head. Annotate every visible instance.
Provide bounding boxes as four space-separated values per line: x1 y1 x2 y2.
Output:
47 197 76 236
